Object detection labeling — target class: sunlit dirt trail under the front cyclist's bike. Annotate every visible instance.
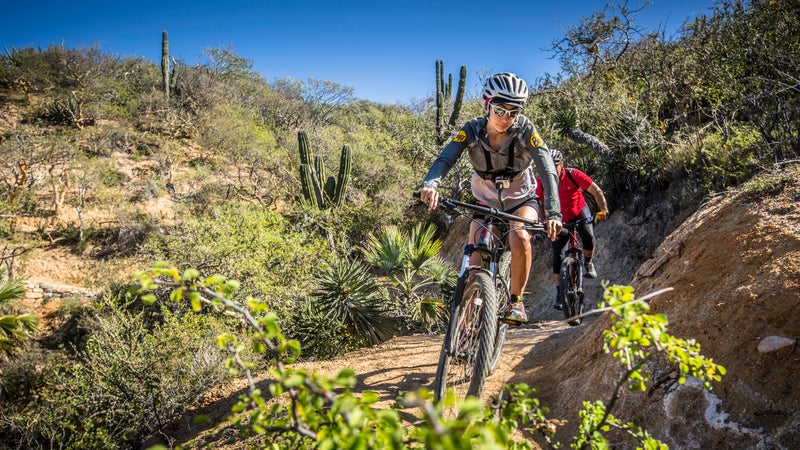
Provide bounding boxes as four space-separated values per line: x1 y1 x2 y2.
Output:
156 318 580 450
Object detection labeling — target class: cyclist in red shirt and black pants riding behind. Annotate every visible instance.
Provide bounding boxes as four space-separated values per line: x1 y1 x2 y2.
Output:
536 149 608 310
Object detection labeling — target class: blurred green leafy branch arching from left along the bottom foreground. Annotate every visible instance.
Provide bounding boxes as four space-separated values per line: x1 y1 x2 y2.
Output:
137 265 555 449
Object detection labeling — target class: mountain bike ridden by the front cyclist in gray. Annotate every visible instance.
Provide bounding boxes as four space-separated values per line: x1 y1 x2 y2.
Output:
418 192 547 411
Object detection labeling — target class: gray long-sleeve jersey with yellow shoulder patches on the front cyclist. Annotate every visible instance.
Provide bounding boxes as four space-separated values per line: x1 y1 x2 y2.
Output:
423 114 561 220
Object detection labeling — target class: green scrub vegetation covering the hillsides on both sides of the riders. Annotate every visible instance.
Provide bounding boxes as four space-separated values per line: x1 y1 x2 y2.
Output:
0 0 800 448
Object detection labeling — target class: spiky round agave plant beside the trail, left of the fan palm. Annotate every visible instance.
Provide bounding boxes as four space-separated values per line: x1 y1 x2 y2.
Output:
312 260 397 345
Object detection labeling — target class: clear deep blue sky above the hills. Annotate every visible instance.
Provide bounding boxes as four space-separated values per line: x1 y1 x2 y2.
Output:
0 0 714 103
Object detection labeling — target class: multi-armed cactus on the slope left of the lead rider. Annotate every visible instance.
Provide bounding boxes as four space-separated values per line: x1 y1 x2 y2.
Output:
297 131 353 209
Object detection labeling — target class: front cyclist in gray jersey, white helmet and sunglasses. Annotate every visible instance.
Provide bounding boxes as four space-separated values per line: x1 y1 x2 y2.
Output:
420 72 561 323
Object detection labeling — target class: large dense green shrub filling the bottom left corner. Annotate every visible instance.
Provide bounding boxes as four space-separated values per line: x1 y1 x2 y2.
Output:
3 294 230 449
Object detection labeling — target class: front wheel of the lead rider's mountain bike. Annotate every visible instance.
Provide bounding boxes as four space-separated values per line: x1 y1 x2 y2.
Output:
434 273 497 417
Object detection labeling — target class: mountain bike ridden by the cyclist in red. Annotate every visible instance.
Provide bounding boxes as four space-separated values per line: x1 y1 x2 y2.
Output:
559 217 592 326
